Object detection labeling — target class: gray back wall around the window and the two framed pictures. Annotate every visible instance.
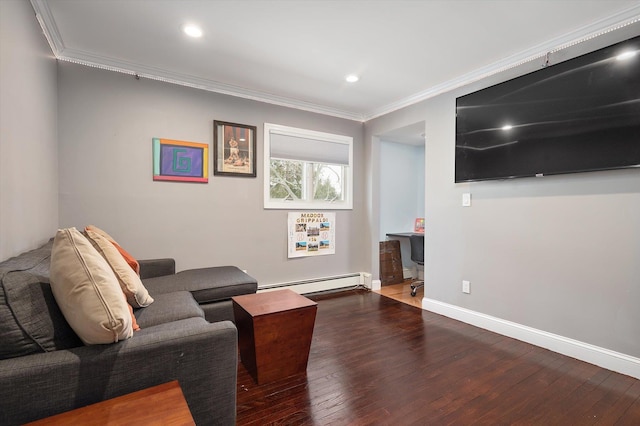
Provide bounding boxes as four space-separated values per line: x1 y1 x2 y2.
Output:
58 63 368 284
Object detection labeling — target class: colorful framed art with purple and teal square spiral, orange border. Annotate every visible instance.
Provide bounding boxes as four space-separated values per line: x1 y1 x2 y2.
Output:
153 138 209 183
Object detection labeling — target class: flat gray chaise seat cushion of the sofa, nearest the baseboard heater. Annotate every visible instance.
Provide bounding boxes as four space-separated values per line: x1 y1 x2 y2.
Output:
143 266 258 304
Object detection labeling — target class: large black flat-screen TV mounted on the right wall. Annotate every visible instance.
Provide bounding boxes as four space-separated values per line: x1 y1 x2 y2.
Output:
455 36 640 182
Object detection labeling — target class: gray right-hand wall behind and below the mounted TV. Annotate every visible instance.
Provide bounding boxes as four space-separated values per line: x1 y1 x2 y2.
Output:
365 24 640 357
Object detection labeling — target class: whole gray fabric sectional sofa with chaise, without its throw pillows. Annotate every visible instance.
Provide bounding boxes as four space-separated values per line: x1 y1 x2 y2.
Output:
0 240 257 425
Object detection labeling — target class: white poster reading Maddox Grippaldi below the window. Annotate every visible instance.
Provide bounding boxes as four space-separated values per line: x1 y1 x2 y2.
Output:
287 212 336 259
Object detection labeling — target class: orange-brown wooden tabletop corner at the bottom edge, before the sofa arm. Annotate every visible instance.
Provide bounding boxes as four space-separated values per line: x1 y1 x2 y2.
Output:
29 381 196 426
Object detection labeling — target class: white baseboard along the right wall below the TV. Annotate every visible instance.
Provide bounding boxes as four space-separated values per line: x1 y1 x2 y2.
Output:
422 297 640 379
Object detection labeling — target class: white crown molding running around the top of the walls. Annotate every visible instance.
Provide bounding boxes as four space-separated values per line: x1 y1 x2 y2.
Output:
30 0 640 122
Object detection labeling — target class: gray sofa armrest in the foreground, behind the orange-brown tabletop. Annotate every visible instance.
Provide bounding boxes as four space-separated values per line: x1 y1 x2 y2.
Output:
0 318 238 425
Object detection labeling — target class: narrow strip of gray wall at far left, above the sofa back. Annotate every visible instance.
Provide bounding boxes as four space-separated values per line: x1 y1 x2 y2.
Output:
0 0 58 261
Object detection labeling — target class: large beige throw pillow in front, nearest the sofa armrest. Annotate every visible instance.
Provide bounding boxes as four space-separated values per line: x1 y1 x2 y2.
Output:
50 228 133 345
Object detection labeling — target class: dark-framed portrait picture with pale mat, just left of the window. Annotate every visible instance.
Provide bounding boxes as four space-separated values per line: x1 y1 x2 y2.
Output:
213 120 257 177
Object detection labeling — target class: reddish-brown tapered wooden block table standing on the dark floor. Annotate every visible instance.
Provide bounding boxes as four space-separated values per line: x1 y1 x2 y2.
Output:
232 290 318 384
